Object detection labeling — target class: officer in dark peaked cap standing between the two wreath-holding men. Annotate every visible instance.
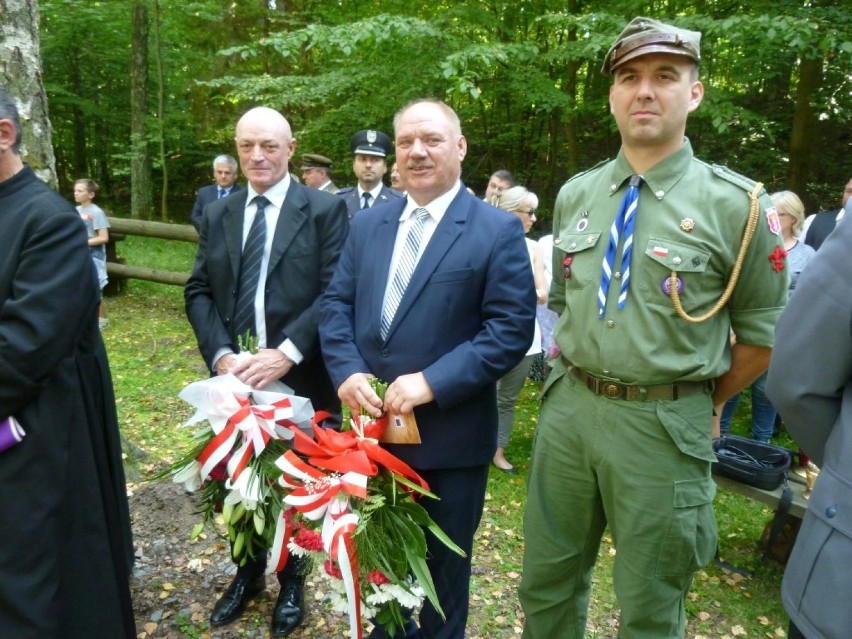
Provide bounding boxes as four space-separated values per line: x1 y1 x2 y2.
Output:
337 129 402 219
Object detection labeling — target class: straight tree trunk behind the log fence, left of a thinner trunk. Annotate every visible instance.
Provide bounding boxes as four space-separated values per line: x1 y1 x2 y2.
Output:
130 0 153 219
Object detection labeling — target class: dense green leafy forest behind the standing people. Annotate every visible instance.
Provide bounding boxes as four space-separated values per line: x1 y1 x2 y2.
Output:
26 0 852 232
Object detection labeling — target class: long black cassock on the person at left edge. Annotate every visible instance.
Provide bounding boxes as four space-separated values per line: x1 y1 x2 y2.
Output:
0 167 136 639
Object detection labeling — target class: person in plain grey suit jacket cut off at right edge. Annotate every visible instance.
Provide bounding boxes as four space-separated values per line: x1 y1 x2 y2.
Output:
766 201 852 639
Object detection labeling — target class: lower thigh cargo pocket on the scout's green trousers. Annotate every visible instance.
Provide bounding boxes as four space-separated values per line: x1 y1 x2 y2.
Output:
656 477 716 577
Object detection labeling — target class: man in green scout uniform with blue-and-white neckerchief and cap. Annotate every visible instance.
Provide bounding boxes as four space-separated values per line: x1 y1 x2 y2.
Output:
520 18 787 639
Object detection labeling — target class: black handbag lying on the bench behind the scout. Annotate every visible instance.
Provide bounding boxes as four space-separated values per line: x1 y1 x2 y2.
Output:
712 435 793 490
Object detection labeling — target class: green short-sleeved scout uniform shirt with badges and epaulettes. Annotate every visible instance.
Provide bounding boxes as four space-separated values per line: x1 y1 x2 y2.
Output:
549 140 787 384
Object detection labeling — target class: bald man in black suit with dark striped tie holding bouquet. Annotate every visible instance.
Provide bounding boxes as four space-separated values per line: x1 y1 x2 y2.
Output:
184 107 349 637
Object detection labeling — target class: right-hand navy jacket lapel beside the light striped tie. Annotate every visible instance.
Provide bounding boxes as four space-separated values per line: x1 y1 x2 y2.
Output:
379 185 470 339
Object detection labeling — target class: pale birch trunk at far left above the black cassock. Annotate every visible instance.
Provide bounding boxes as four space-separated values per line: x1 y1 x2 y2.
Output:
0 0 56 188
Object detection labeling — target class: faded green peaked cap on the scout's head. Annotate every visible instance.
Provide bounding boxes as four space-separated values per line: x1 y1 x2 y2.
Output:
601 17 701 74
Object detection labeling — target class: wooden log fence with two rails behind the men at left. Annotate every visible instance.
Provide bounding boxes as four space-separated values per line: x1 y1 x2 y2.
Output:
106 217 198 295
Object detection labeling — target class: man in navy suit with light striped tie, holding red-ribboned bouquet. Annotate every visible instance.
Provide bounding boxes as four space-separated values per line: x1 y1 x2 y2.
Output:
320 100 535 639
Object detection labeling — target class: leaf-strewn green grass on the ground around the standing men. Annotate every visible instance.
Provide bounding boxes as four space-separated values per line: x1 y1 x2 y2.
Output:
103 237 795 639
